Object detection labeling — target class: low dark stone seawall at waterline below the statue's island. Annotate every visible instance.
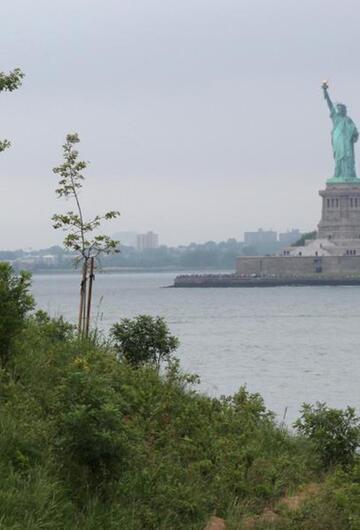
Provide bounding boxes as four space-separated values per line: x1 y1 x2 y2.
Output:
171 274 360 287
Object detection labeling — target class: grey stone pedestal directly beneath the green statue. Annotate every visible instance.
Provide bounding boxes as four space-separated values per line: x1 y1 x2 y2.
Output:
317 179 360 240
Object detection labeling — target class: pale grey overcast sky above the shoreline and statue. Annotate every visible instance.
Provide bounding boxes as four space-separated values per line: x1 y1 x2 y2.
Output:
0 0 360 248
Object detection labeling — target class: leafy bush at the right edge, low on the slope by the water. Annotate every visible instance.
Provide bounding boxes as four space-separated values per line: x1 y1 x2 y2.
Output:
294 403 360 467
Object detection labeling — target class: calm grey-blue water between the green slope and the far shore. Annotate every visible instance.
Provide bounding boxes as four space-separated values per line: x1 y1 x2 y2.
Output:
33 273 360 421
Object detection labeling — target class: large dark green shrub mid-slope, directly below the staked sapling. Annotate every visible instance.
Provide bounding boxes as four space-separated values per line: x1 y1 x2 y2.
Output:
53 351 132 489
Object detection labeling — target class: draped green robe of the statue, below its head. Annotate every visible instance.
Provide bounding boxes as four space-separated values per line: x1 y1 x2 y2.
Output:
330 108 359 180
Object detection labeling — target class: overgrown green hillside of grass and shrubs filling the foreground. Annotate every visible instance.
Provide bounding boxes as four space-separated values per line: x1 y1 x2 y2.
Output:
0 266 360 530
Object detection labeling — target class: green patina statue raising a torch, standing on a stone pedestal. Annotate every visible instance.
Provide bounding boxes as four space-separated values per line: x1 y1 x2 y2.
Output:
322 81 360 183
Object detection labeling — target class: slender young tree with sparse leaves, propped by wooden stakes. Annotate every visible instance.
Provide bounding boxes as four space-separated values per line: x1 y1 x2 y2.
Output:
52 133 120 337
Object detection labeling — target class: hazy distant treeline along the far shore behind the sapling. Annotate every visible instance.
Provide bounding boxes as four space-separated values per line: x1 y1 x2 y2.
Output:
0 239 282 271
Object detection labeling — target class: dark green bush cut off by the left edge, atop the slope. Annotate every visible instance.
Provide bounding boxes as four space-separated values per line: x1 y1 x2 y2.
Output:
0 263 34 367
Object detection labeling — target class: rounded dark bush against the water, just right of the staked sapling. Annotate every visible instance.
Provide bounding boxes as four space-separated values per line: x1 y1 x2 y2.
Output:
111 315 179 368
